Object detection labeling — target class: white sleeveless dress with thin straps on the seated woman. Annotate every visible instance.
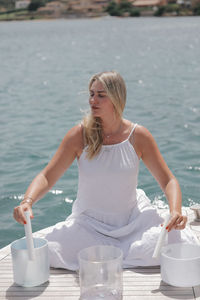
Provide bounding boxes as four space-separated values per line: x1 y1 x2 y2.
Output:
45 124 196 270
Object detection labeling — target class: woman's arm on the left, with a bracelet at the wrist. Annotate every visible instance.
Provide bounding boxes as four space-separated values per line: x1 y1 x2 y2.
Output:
13 125 83 224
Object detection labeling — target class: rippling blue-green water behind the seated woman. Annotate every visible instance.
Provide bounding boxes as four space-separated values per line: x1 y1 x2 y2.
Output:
0 17 200 247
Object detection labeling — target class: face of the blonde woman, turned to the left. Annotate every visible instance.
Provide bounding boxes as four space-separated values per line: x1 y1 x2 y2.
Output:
89 80 115 118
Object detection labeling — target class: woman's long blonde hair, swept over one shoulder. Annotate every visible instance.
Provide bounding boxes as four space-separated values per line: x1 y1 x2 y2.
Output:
82 71 126 159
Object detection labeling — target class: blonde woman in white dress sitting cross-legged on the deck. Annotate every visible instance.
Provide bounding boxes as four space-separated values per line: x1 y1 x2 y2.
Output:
14 72 195 270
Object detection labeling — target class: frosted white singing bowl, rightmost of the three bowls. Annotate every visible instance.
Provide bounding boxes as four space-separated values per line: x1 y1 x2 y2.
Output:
161 243 200 287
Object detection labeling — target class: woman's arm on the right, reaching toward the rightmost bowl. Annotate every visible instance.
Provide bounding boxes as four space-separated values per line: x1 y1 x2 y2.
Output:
134 126 187 231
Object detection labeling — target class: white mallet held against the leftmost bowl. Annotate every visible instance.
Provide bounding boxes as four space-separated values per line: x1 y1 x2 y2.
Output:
24 211 35 260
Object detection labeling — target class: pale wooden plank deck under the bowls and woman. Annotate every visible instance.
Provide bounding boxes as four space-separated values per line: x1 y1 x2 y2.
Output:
0 209 200 300
